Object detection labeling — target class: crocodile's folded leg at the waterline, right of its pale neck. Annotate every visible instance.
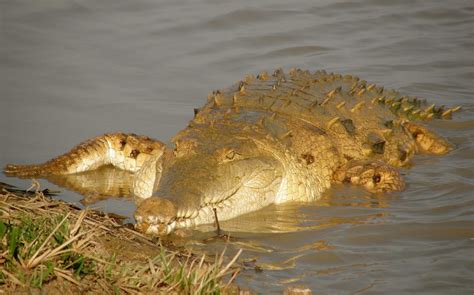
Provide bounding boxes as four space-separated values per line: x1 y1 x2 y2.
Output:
333 160 405 192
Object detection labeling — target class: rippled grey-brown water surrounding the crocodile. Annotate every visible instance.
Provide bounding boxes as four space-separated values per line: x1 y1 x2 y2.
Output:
0 0 474 294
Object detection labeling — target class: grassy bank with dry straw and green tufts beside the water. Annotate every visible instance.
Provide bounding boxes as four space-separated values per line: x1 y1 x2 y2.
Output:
0 186 240 294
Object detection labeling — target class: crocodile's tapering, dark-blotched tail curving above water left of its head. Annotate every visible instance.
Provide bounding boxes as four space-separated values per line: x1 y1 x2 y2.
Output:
4 133 165 177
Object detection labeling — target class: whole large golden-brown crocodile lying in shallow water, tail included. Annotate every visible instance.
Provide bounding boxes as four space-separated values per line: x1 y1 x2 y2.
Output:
4 69 460 235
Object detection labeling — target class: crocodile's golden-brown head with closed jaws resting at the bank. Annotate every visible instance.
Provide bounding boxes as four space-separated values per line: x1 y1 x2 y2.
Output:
135 122 284 235
